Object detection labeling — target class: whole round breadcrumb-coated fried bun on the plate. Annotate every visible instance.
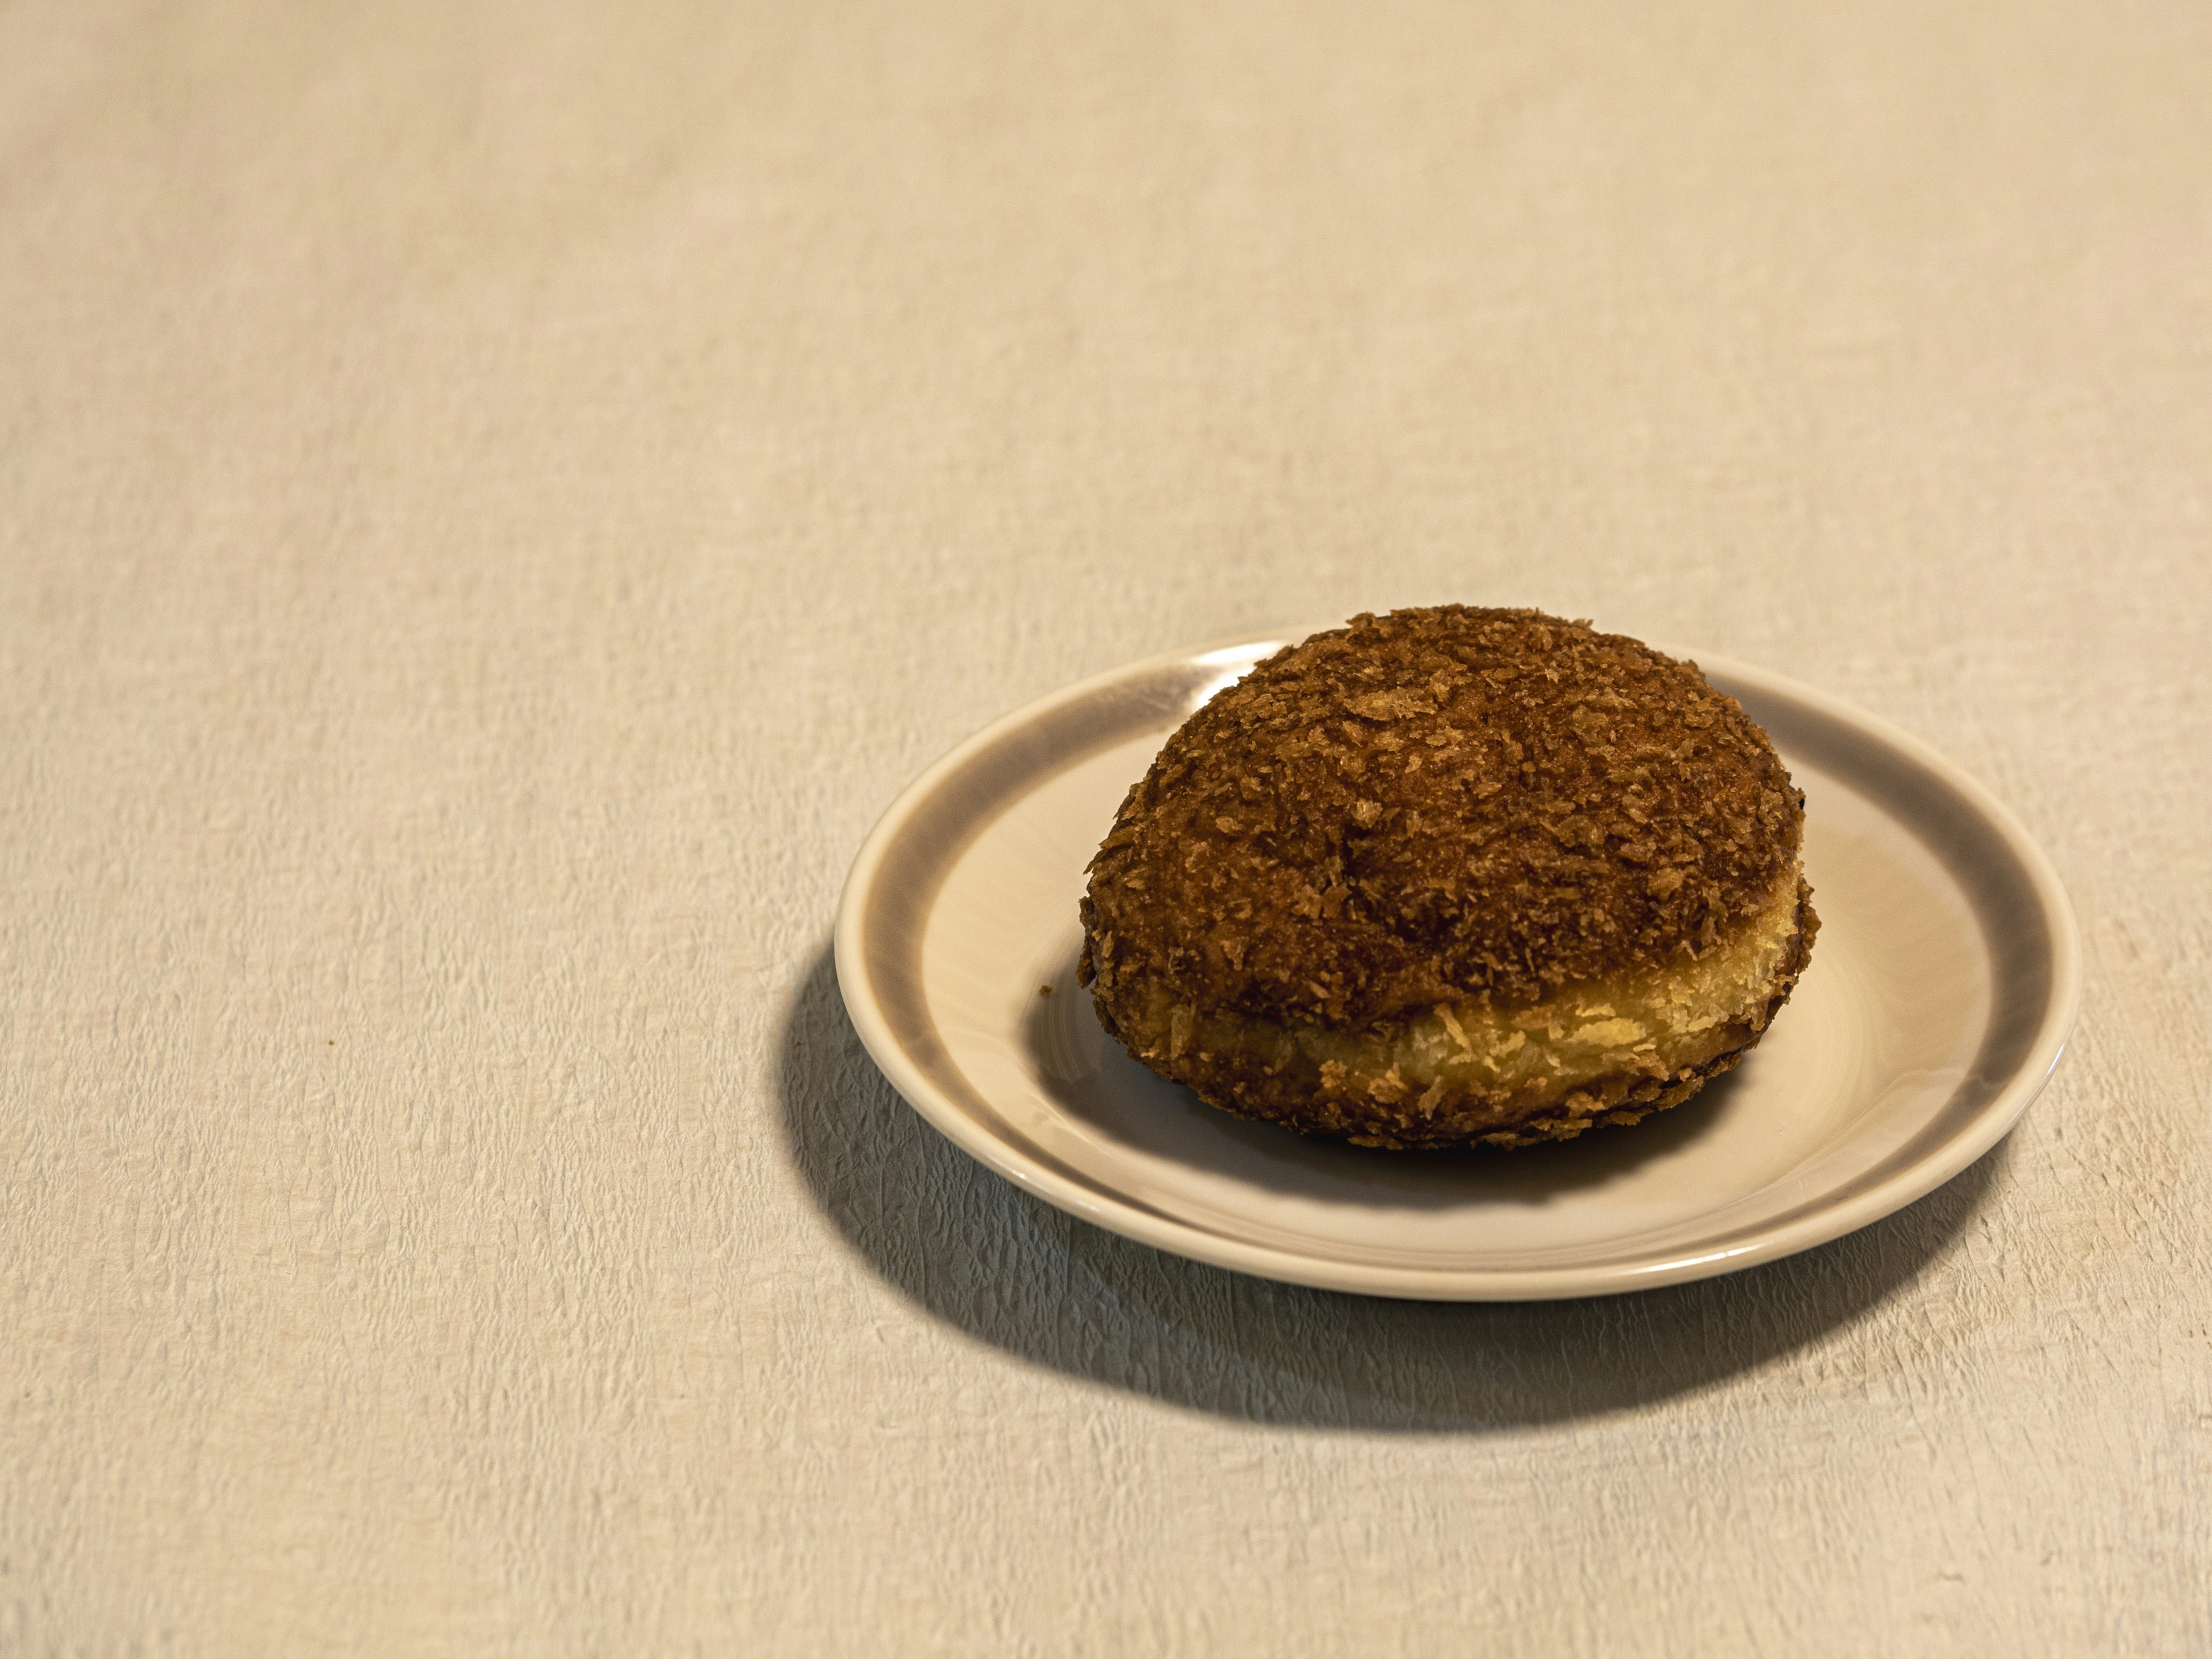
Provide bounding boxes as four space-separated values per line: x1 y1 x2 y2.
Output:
1077 606 1818 1148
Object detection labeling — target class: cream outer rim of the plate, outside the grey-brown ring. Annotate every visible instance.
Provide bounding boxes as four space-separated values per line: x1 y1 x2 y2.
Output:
832 624 2081 1301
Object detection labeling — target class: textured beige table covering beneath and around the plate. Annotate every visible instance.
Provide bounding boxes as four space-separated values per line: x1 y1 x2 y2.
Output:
0 0 2212 1654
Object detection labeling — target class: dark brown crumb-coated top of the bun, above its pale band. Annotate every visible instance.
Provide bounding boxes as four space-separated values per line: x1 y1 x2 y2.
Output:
1084 606 1803 1027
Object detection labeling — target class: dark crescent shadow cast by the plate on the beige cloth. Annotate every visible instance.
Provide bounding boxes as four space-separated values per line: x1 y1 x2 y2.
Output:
779 951 2009 1431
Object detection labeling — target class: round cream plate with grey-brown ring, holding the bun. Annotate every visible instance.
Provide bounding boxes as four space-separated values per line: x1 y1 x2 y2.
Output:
836 635 2081 1301
